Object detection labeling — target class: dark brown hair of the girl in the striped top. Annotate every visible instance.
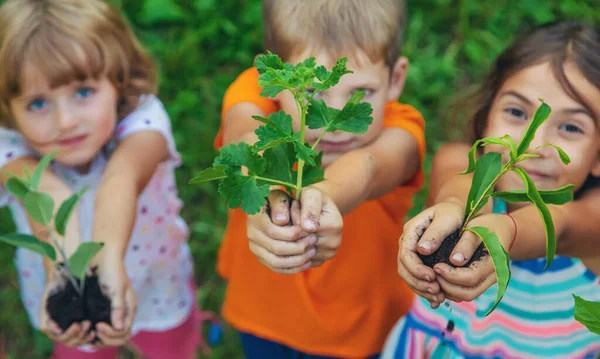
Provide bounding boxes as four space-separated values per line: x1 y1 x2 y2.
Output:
464 21 600 141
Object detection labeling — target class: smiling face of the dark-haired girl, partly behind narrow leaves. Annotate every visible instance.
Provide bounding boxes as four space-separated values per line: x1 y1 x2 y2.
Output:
484 63 600 197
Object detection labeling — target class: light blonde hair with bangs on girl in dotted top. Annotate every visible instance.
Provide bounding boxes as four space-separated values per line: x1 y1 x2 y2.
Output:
0 0 157 126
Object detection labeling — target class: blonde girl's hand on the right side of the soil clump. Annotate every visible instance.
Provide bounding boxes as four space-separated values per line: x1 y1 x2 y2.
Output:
91 252 136 349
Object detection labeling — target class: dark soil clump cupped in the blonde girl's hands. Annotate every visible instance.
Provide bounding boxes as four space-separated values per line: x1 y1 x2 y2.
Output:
46 274 112 331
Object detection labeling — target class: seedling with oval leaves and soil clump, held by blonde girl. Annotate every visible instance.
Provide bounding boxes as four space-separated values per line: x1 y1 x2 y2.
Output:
0 153 110 330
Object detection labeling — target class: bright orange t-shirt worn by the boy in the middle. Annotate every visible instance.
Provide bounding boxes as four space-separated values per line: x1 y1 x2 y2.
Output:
215 68 425 358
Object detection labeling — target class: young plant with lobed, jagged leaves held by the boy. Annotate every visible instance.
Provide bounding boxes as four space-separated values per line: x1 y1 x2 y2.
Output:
190 52 373 214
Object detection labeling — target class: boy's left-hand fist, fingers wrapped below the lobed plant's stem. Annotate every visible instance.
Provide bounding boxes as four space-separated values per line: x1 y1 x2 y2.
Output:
247 190 317 274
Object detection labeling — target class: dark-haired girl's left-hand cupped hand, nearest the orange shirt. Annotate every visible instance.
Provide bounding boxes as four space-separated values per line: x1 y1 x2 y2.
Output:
398 199 464 308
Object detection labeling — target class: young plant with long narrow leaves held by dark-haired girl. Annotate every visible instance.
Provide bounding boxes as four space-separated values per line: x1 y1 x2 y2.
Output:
420 100 574 315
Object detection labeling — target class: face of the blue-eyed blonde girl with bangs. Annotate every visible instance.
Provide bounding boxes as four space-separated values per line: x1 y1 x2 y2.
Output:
10 64 117 172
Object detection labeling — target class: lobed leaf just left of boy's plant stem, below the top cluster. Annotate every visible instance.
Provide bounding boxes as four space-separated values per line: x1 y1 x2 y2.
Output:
252 111 294 150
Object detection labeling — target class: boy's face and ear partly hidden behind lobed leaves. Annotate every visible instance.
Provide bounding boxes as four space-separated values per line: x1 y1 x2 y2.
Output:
278 51 408 166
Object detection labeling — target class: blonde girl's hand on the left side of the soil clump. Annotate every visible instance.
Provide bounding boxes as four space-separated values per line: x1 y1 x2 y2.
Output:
39 265 95 348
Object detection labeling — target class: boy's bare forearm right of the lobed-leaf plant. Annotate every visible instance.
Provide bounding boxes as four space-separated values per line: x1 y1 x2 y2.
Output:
314 128 420 214
